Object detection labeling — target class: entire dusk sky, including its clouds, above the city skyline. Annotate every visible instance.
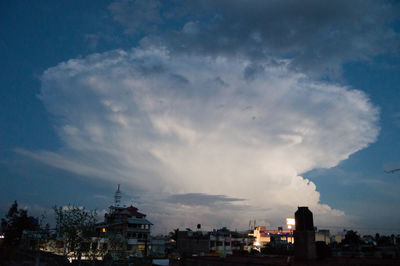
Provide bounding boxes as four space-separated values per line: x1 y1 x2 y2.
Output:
0 0 400 232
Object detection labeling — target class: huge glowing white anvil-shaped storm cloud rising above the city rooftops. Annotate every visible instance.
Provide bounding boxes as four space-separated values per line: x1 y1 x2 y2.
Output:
28 48 378 233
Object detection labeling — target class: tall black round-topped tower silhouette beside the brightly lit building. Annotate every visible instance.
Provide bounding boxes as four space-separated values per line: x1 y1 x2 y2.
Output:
294 207 317 260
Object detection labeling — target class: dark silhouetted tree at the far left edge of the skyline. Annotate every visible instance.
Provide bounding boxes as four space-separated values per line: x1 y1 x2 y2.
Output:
1 201 39 246
